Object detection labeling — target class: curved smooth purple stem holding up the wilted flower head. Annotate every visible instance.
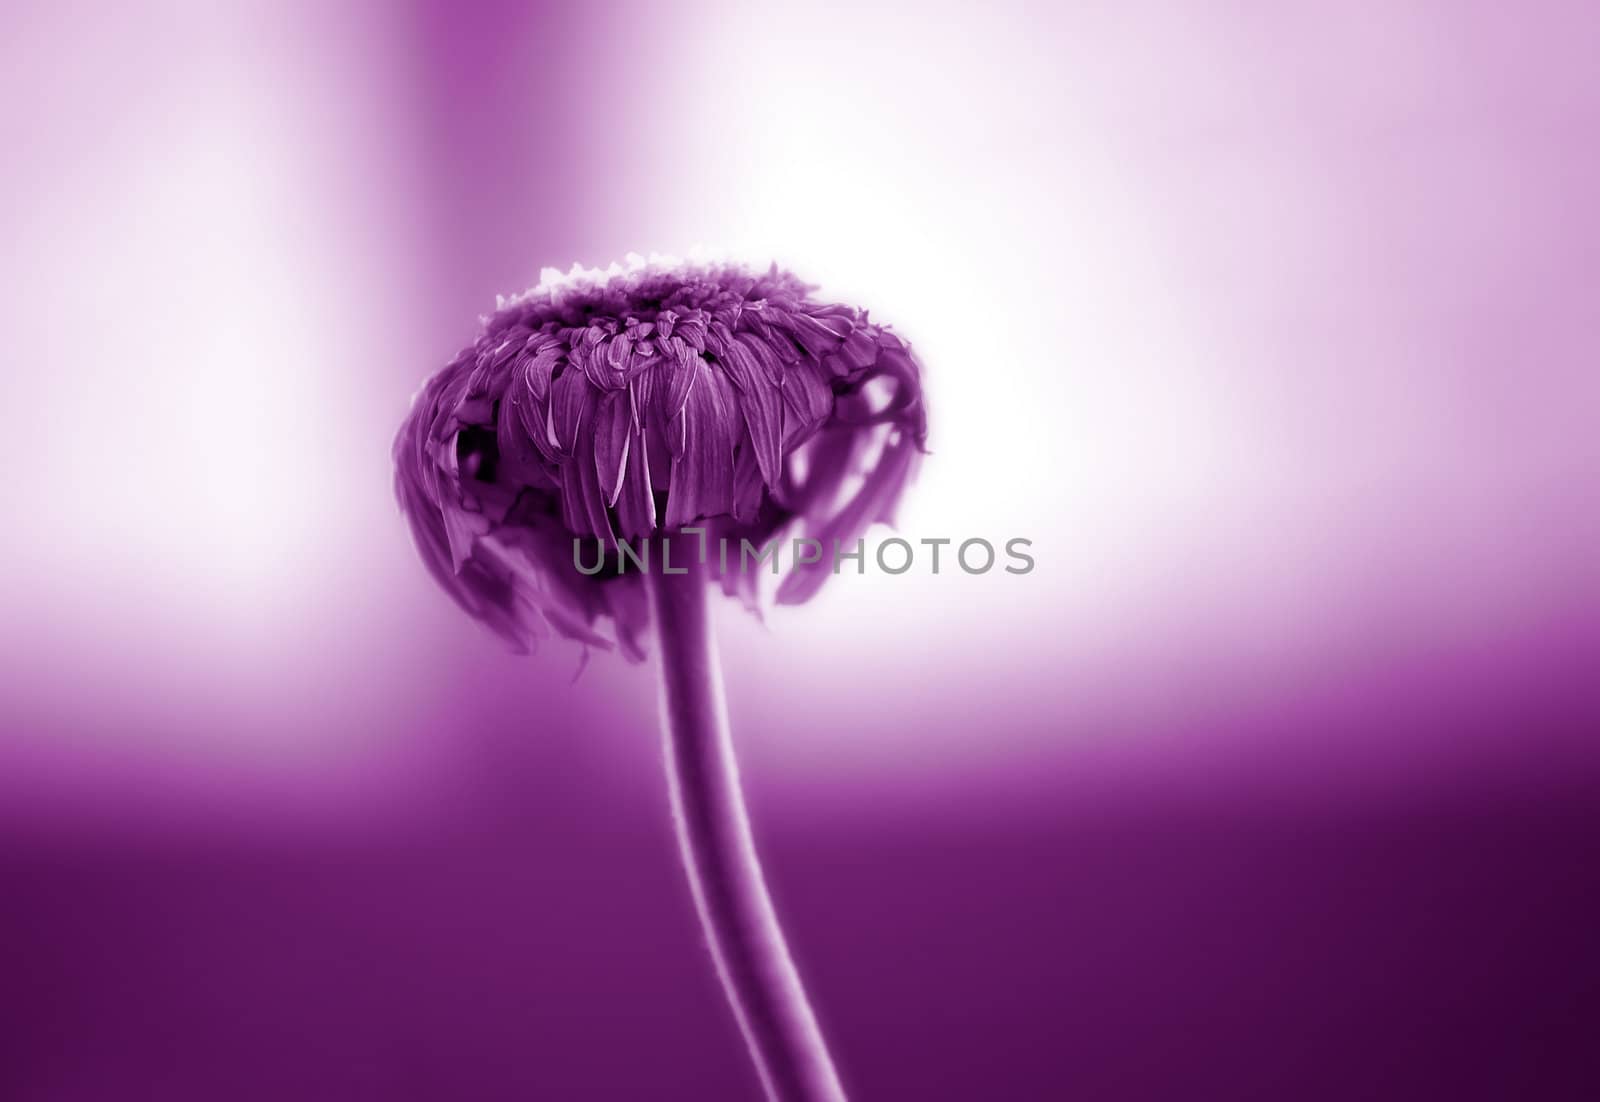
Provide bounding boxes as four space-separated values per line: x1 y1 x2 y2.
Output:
648 534 845 1102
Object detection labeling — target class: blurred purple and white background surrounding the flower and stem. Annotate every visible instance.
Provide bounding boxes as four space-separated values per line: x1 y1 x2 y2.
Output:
0 0 1600 1102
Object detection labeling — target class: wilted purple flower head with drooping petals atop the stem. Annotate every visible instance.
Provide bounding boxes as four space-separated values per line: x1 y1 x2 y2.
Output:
394 258 926 661
